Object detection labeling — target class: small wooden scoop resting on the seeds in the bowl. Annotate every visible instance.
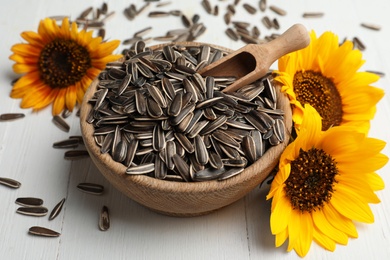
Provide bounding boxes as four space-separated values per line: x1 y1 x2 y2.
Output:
199 24 310 92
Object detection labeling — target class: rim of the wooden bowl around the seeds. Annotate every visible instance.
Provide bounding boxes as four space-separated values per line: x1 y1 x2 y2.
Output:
80 42 292 197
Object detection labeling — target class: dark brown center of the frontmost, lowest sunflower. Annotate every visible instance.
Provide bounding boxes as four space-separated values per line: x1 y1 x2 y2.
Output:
284 148 338 212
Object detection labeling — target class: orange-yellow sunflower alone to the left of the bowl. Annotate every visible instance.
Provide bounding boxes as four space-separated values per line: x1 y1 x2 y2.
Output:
10 18 121 115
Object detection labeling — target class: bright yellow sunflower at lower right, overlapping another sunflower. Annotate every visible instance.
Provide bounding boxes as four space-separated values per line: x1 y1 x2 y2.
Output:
267 105 388 256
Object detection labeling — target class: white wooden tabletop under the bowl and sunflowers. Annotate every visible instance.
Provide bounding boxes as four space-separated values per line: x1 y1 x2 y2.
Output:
0 0 390 259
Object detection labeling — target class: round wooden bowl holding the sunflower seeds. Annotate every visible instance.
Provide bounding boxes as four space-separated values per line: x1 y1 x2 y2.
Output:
80 42 292 217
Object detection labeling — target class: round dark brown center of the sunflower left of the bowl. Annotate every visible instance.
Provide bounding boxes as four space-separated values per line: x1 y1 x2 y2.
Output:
39 39 91 88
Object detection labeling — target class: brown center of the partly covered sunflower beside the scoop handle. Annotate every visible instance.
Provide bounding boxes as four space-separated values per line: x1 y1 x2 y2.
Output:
293 70 343 131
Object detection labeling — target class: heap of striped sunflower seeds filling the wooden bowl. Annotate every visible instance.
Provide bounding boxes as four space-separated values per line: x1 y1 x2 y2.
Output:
87 41 285 182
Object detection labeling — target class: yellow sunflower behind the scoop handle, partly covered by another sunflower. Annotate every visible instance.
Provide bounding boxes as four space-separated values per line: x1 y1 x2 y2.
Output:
275 31 384 133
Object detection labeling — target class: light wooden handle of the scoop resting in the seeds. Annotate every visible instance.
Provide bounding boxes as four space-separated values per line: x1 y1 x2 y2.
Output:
257 24 310 68
